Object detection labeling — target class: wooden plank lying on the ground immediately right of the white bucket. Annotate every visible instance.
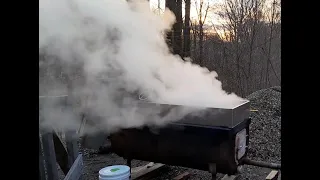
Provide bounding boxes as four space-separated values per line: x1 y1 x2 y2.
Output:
131 163 164 180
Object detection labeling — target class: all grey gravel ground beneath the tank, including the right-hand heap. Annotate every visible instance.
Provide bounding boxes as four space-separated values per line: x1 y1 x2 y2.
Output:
62 87 281 180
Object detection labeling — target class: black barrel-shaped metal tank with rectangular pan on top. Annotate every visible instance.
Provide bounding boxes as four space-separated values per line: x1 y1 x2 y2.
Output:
109 101 251 175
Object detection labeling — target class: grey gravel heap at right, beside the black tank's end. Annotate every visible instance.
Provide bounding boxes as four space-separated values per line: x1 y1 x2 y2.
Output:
239 87 281 180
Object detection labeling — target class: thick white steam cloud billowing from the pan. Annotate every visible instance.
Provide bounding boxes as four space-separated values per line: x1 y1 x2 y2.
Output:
39 0 242 132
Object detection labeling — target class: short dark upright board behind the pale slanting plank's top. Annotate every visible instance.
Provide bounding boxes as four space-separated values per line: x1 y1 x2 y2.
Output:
65 131 79 167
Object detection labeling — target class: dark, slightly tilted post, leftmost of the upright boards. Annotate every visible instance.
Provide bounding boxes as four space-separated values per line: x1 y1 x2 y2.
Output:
42 132 59 180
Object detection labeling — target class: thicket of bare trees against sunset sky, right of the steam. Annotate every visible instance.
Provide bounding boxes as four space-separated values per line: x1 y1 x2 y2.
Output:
162 0 281 96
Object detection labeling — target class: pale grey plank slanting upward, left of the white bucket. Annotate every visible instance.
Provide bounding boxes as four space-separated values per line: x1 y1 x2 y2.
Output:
64 154 83 180
